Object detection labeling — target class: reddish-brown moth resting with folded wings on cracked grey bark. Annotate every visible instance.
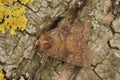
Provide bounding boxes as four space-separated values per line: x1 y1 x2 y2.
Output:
36 23 91 67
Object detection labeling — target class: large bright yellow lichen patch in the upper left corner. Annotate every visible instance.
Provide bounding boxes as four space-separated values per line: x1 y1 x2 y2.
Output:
0 0 33 35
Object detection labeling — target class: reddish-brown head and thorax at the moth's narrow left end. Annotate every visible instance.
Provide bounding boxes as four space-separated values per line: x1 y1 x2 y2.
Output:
36 35 52 51
